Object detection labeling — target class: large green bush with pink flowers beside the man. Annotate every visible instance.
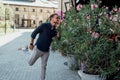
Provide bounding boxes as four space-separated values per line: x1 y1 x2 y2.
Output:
52 1 120 80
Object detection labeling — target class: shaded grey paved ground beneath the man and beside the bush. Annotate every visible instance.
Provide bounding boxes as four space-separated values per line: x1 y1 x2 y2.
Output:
0 31 80 80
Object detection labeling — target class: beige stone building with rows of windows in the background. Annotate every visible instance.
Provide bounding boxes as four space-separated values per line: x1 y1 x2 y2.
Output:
3 0 58 28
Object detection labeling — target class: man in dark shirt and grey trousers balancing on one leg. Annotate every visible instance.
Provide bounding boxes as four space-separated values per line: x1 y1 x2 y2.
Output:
29 14 60 80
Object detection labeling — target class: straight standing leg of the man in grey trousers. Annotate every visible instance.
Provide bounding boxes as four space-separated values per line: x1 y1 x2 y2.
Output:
41 52 49 80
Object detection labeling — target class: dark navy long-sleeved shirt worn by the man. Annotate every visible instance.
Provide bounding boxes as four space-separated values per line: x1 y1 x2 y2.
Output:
31 23 57 52
